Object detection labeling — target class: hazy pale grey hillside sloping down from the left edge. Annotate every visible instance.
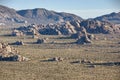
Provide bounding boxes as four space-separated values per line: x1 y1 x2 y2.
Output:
0 5 24 23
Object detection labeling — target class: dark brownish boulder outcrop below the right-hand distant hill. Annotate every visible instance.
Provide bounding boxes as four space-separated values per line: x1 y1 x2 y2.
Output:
80 20 120 34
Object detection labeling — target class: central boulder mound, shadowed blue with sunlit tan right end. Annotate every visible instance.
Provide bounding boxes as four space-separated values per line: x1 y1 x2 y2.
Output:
39 22 76 35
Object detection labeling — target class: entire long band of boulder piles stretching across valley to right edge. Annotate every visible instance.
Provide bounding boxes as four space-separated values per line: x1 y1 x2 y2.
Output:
12 19 120 36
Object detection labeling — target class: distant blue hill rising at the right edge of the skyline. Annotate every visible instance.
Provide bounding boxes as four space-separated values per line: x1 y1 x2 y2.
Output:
95 12 120 24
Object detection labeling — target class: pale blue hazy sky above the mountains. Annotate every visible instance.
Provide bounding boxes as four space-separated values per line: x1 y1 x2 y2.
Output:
0 0 120 18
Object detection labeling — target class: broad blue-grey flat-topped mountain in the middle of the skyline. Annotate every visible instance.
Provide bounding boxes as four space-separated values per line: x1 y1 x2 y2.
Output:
17 8 83 24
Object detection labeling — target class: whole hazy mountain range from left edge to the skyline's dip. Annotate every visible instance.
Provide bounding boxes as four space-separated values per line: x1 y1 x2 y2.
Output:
0 5 83 24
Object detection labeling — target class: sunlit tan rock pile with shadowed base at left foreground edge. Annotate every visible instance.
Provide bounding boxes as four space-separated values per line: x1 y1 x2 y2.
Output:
0 42 29 61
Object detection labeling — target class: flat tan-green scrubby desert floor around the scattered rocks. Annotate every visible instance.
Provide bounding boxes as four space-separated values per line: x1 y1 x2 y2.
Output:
0 28 120 80
